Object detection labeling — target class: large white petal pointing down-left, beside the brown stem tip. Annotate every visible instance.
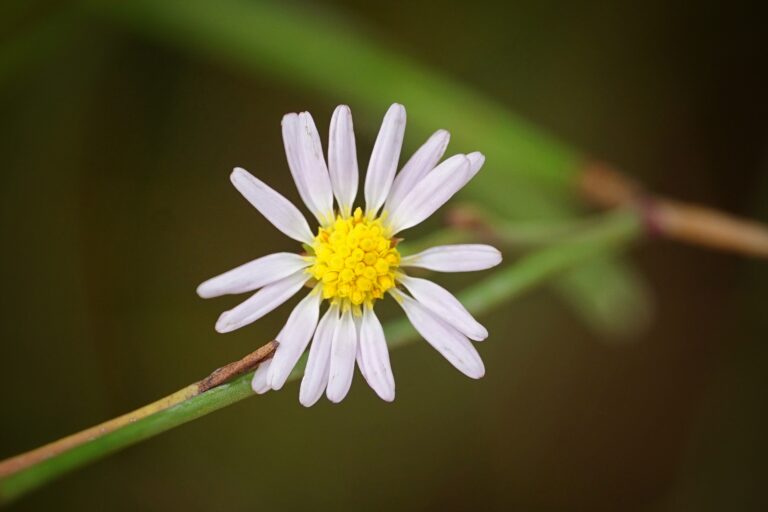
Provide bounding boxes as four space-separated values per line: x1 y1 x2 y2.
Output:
267 289 322 389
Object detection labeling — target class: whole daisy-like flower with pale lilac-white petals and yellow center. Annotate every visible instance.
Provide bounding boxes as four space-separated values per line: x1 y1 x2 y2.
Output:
197 104 501 406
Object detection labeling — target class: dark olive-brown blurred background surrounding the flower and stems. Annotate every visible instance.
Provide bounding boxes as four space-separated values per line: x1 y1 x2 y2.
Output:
0 0 768 511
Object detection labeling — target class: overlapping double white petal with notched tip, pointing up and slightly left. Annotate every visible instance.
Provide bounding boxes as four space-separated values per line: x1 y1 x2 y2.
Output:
282 112 333 225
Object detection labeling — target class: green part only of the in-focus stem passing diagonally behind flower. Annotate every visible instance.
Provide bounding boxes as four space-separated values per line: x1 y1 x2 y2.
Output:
0 211 642 503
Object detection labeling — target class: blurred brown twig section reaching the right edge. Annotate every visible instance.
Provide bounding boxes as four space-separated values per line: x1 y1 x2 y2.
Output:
578 162 768 258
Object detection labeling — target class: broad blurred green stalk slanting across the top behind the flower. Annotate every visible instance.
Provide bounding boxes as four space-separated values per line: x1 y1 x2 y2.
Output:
84 0 583 192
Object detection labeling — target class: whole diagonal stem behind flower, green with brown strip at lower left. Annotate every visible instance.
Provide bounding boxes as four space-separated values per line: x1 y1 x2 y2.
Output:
0 211 642 504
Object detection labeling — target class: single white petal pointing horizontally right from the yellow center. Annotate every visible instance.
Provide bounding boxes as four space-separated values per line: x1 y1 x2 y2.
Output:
400 244 501 272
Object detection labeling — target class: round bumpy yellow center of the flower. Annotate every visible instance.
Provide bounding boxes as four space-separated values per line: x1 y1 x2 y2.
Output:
308 208 400 310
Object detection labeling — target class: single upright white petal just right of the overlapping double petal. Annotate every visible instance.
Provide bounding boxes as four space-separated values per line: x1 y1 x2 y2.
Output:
328 105 358 216
